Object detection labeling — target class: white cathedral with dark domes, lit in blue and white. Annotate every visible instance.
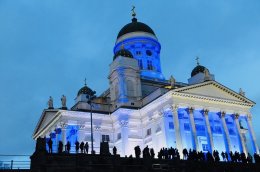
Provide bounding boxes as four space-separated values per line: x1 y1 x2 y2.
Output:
33 12 259 157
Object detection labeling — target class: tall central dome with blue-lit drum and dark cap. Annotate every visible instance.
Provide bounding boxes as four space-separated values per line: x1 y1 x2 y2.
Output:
114 16 165 81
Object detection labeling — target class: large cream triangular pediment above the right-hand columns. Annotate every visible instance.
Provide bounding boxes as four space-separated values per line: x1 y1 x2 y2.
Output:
174 81 255 105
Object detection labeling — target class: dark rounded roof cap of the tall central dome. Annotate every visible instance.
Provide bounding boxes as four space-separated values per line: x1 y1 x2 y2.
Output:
117 18 155 38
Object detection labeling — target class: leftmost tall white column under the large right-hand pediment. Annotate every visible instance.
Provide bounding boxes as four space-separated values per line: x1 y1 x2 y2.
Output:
172 106 183 157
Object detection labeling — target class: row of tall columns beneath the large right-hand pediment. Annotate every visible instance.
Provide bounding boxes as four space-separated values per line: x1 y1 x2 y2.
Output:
171 106 259 155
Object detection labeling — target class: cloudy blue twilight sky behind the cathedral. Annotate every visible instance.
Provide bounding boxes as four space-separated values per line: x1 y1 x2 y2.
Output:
0 0 260 154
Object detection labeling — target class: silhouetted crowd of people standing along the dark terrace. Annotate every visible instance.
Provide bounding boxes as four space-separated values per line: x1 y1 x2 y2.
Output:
47 139 260 163
